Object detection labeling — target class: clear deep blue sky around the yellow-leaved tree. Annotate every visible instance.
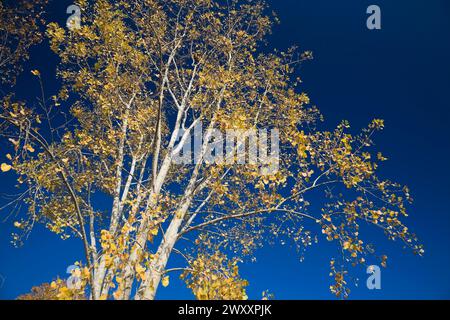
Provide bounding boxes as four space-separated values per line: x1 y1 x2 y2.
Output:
0 0 450 299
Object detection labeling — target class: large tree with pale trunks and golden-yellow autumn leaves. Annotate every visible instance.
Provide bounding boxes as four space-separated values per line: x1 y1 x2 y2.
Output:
0 0 423 300
